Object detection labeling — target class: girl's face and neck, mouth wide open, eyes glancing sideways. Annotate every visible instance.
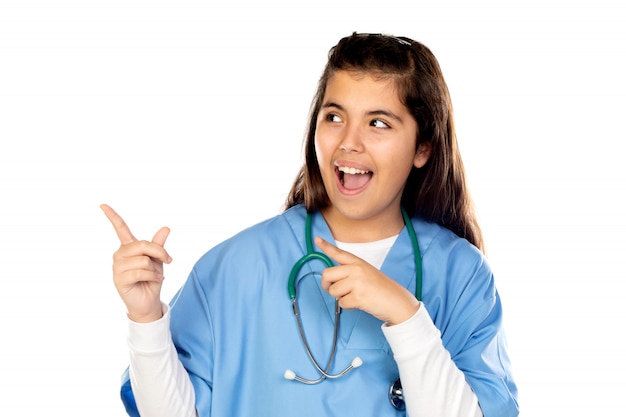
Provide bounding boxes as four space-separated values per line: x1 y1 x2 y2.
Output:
315 71 430 241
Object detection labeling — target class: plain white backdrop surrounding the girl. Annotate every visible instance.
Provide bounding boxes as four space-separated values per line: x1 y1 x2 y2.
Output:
0 0 626 417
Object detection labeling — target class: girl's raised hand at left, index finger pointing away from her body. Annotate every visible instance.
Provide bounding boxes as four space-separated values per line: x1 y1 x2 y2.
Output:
100 204 172 323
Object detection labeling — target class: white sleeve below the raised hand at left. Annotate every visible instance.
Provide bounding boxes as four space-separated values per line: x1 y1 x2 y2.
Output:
127 304 197 417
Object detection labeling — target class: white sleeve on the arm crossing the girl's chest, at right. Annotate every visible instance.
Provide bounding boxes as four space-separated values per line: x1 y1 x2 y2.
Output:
382 304 483 417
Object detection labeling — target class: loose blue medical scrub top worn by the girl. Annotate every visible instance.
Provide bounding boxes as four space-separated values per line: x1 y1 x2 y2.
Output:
122 206 518 417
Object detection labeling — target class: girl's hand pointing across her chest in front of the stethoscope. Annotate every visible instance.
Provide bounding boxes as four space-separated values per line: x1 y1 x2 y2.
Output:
315 237 420 325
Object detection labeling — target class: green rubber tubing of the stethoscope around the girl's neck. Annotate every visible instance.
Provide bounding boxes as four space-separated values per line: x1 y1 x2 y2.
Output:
287 208 422 301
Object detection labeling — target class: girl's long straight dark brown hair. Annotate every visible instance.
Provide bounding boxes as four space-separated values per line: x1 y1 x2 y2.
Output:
285 33 484 250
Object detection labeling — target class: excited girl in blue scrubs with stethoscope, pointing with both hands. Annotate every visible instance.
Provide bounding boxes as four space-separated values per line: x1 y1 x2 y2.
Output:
102 33 518 417
